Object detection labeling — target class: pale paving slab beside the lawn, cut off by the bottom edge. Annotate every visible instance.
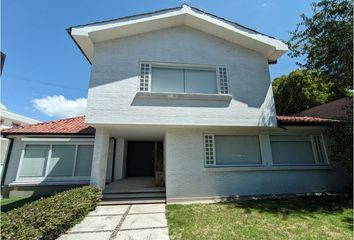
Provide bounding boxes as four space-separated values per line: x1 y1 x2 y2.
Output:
115 228 169 240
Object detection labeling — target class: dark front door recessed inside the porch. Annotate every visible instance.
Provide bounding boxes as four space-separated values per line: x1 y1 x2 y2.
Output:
126 141 155 177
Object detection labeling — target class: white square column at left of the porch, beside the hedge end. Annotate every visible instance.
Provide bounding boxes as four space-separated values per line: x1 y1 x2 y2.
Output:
90 128 109 190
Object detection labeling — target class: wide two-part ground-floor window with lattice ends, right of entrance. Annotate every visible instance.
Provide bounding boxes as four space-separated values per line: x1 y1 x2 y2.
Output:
204 134 328 167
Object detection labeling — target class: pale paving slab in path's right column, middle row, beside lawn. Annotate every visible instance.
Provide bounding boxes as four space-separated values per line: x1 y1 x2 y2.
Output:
121 213 167 229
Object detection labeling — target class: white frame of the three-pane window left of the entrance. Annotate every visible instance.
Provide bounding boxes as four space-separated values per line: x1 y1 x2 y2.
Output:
16 139 94 182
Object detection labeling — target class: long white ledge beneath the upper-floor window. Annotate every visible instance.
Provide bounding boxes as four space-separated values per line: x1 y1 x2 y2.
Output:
136 92 232 101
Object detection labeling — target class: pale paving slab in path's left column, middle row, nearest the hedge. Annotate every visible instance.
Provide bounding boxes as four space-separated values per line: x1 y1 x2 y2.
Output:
69 216 122 232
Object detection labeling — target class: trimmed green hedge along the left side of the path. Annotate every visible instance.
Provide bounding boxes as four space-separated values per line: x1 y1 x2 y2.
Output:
1 186 101 240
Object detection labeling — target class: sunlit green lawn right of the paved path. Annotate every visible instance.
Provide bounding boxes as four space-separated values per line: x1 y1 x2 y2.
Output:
167 195 353 240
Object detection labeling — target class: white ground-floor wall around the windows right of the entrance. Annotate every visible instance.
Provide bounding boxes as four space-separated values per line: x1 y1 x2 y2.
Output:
165 128 345 202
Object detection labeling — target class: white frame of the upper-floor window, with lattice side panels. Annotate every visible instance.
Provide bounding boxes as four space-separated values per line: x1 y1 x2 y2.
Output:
138 61 230 95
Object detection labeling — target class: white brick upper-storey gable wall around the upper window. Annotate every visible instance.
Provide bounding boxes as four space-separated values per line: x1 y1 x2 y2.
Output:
86 27 276 126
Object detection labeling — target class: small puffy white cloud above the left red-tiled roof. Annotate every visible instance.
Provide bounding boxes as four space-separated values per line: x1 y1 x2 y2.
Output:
32 95 87 118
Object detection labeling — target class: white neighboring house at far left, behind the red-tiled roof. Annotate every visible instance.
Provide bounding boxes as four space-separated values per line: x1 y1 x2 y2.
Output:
0 109 39 178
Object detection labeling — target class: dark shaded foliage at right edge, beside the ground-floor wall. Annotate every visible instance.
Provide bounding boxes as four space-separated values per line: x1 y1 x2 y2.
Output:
327 98 353 172
